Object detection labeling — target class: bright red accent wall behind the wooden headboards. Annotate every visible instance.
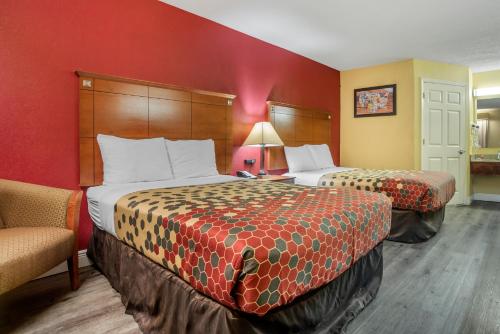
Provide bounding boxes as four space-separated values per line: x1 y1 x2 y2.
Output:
0 0 340 249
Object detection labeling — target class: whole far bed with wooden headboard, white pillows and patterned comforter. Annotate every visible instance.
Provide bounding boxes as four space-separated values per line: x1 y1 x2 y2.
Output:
268 101 455 243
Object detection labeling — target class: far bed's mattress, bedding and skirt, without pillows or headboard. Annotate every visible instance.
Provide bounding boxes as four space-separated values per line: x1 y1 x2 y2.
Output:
285 167 455 243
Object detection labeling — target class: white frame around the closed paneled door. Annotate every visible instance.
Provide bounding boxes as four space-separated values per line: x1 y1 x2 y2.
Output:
420 78 470 205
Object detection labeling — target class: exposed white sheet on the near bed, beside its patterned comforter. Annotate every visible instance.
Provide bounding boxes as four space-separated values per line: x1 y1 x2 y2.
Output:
87 175 242 236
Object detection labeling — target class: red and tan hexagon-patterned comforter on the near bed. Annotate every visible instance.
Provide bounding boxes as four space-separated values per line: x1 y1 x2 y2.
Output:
115 181 391 315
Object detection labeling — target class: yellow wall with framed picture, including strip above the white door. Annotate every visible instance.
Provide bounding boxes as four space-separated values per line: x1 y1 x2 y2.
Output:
340 59 470 169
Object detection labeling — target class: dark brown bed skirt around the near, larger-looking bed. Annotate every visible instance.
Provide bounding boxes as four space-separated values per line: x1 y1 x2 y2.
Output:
88 227 383 334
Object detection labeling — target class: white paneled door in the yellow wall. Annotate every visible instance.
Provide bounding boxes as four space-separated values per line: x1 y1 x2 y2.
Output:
422 80 467 204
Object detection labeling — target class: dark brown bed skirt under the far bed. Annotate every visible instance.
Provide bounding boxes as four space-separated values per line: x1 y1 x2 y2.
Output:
387 207 445 244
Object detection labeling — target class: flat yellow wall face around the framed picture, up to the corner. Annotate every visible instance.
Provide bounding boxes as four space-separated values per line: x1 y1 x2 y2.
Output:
340 60 415 169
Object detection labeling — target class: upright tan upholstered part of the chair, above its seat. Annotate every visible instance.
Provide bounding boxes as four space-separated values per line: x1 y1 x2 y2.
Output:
0 179 82 232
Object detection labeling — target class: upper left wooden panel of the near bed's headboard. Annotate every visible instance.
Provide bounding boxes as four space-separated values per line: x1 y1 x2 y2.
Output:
94 92 148 138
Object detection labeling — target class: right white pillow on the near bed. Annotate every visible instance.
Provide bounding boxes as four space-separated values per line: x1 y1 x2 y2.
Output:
165 139 219 179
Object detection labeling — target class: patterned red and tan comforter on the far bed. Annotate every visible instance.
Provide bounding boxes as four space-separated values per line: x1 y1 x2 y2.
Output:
318 169 455 212
